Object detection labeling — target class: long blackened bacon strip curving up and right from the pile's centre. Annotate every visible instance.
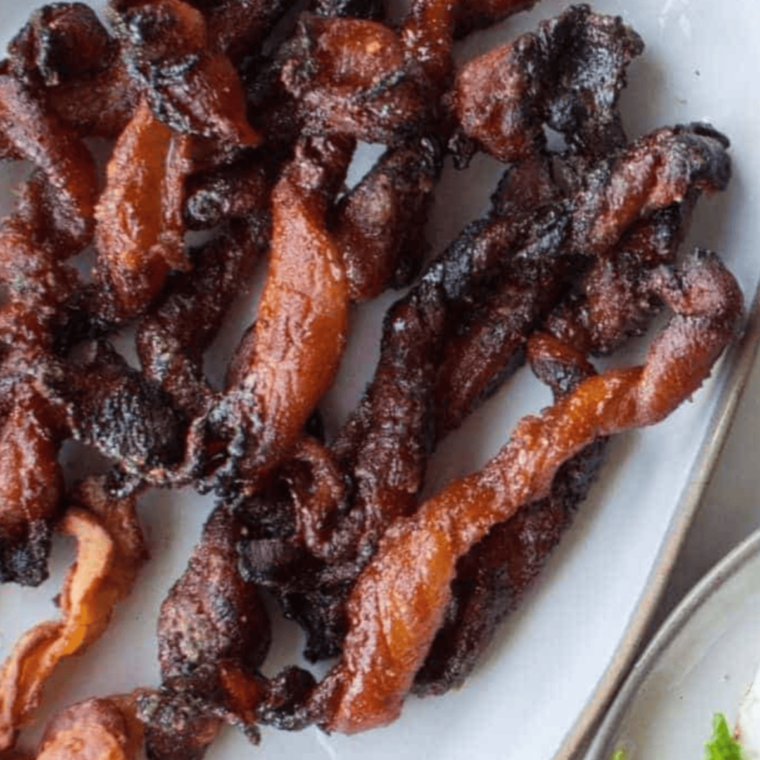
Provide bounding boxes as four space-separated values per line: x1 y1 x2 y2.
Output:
334 196 568 532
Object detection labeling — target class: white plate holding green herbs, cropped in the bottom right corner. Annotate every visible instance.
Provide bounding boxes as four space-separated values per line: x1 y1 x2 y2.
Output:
587 531 760 760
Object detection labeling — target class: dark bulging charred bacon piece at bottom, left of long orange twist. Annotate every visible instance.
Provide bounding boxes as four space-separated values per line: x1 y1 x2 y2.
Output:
140 506 271 760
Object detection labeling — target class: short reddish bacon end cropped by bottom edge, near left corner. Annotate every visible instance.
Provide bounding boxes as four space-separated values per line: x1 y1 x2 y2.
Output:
36 696 143 760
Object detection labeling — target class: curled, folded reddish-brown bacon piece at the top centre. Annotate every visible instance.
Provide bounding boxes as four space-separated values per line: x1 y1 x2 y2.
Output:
282 0 529 144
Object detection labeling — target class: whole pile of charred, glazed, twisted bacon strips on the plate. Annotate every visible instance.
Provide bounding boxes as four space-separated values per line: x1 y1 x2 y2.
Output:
0 0 742 760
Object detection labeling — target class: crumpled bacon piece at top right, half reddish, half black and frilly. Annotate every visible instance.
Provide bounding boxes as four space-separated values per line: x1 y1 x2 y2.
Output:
452 5 644 163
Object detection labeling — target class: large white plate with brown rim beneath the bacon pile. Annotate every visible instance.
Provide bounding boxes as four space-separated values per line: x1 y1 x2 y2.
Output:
0 0 760 760
